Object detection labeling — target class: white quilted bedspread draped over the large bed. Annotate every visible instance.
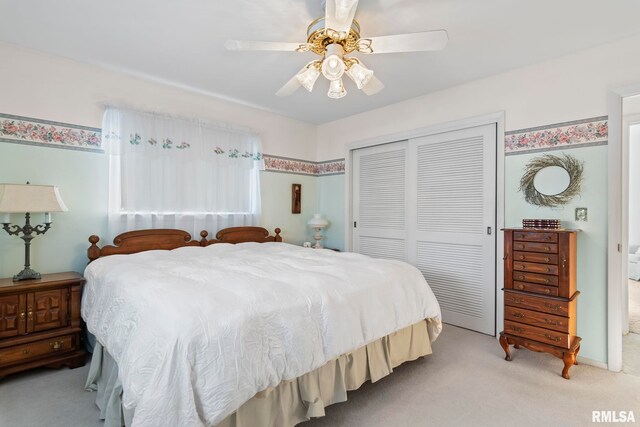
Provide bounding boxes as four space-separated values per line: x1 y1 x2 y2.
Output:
82 243 440 427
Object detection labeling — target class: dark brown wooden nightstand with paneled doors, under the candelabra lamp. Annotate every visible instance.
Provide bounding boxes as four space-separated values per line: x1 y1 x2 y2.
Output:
0 272 86 378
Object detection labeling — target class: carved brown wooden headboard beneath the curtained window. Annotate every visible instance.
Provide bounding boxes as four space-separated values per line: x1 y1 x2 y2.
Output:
87 227 282 262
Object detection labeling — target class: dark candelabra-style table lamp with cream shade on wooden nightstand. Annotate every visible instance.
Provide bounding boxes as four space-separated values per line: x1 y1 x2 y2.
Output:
0 182 67 281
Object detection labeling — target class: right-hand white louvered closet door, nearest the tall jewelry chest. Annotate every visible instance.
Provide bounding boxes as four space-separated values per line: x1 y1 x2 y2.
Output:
409 125 496 335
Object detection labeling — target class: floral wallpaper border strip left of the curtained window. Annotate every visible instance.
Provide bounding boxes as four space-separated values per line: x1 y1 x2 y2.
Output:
0 113 103 153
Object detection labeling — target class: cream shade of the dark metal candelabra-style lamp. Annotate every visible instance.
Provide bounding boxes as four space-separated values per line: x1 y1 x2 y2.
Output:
0 184 68 213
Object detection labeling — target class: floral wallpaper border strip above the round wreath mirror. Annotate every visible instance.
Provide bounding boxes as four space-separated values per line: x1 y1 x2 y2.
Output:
504 116 609 156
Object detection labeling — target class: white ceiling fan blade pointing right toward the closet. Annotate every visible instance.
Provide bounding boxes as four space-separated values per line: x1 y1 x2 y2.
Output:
358 30 449 53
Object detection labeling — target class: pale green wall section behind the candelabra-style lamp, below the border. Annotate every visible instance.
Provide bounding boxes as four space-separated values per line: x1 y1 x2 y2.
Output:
0 143 108 277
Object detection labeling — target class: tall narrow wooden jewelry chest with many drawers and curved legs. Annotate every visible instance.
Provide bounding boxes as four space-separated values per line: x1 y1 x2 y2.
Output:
500 229 581 379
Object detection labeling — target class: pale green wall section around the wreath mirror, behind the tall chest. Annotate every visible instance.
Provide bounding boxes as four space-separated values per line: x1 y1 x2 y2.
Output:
505 146 608 363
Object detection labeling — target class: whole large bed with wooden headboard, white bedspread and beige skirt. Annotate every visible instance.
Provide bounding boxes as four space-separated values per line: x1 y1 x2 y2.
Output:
82 227 441 427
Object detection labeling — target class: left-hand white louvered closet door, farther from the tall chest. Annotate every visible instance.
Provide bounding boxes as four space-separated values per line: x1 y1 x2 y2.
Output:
353 141 408 261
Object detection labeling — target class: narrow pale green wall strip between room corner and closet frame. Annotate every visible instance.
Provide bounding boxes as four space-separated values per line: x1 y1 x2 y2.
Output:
318 175 345 250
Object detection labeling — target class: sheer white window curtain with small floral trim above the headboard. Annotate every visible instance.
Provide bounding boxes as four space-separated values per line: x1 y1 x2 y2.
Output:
102 107 264 238
